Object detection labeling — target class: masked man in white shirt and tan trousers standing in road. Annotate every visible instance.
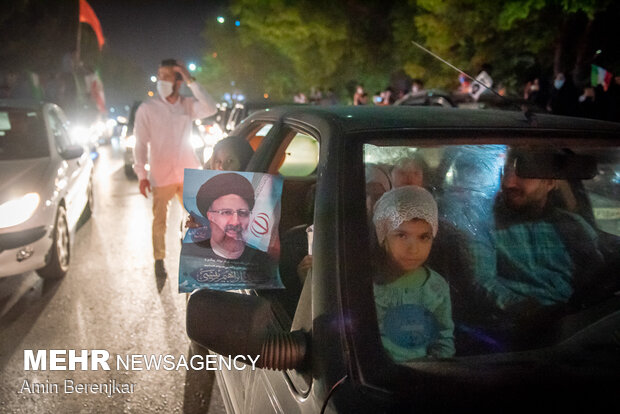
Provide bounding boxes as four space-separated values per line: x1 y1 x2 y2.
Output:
134 59 217 277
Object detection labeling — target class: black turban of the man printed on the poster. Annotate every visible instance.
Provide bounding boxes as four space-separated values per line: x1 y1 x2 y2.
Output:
196 173 254 217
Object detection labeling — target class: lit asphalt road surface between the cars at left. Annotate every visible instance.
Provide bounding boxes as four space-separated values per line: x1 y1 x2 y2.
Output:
0 146 224 413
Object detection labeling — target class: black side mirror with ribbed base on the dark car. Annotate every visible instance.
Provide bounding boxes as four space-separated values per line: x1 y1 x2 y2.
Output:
187 289 307 370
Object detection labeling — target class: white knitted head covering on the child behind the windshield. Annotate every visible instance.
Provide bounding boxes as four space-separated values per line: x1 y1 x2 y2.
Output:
372 185 437 244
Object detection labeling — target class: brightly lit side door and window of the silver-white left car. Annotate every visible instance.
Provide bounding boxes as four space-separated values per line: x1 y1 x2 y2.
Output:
46 105 91 227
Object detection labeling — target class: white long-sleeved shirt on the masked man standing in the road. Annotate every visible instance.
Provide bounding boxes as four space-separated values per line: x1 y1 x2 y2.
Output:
134 81 217 187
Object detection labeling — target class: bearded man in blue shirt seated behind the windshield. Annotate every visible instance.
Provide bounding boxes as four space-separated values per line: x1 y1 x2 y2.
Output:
472 149 603 326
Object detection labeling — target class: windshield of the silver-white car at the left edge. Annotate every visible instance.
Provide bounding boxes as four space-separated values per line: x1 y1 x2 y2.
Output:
0 108 49 161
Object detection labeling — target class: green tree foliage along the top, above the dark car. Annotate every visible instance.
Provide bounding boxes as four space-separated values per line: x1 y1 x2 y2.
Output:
205 0 620 98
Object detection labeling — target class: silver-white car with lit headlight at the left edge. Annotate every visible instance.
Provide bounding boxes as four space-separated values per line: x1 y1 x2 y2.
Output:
0 100 94 278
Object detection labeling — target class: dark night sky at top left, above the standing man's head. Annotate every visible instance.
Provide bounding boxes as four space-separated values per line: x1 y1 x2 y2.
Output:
88 0 227 73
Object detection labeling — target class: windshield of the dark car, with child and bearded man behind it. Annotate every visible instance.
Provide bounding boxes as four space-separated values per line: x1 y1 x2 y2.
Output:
364 141 620 362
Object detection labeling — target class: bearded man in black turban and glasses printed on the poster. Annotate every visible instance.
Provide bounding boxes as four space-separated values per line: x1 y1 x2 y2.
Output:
181 173 275 283
